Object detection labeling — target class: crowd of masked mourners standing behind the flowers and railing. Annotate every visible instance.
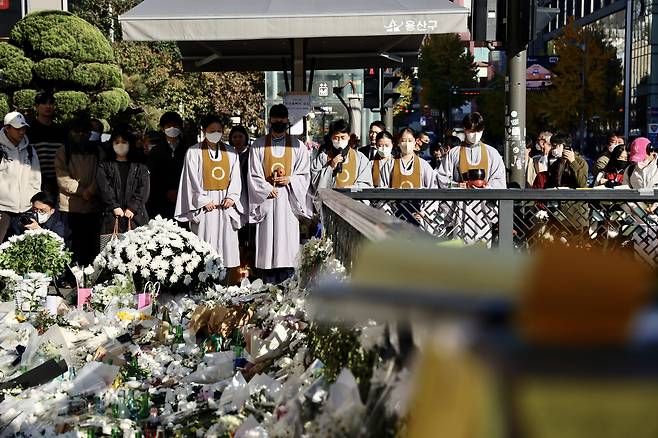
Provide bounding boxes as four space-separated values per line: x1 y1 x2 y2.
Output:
0 92 658 281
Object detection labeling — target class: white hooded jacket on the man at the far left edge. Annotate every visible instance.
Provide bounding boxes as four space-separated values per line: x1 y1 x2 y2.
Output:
0 128 41 213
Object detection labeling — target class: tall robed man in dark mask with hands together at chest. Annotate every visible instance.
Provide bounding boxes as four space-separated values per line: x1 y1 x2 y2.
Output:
248 104 311 282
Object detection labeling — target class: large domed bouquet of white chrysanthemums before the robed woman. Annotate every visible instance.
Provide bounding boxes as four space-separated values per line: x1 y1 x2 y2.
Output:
94 216 225 292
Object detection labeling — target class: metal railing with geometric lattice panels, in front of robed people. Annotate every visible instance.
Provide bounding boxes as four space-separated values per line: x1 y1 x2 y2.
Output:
340 189 658 267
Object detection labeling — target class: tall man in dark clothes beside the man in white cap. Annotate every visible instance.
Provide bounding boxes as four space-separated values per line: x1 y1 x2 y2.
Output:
27 91 67 199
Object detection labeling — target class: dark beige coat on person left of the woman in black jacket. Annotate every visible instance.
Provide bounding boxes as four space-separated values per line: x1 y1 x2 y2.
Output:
55 146 98 213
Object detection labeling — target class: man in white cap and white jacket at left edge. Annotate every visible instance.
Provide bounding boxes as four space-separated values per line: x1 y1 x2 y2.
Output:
0 112 41 242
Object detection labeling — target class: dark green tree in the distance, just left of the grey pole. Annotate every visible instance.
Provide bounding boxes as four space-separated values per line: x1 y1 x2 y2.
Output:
418 33 477 133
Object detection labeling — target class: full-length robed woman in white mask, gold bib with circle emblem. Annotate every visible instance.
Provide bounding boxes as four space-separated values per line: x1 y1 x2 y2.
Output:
175 116 244 268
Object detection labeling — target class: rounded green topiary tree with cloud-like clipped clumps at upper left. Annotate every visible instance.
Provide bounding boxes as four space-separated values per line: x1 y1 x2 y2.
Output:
0 11 130 121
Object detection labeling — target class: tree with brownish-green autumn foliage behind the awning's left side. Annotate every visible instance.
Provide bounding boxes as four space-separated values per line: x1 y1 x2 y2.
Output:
69 0 265 130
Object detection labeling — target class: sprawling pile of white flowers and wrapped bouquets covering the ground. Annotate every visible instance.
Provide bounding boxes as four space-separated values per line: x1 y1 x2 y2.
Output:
0 241 409 437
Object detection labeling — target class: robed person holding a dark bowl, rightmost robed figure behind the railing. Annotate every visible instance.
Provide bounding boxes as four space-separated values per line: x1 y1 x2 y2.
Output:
435 113 507 243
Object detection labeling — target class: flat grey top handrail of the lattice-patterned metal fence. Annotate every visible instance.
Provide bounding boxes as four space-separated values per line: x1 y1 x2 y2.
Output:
334 189 658 202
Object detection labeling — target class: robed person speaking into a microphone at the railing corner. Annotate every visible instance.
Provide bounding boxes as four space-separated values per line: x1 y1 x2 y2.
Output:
311 119 372 212
